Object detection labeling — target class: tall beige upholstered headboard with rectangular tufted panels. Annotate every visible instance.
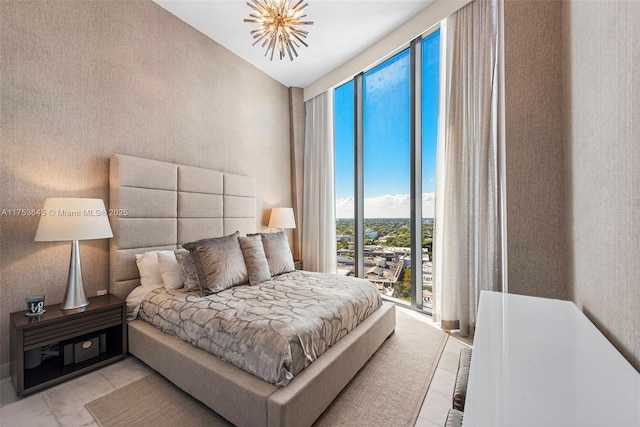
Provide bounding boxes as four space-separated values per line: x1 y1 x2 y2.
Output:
109 154 256 298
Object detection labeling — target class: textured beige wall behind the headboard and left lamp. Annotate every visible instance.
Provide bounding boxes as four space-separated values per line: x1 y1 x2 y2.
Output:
0 1 303 368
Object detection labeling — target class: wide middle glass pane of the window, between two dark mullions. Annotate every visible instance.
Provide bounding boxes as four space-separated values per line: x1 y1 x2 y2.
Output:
363 49 411 302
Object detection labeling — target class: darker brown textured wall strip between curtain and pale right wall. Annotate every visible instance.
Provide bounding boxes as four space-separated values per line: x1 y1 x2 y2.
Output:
504 0 568 299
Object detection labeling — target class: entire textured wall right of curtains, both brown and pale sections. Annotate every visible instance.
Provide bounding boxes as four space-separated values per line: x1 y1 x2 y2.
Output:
505 0 640 370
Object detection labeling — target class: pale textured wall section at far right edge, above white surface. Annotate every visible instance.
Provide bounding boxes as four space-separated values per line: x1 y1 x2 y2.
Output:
563 0 640 370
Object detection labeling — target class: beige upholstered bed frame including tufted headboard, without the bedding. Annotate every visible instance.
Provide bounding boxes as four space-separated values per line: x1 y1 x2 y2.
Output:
109 155 395 426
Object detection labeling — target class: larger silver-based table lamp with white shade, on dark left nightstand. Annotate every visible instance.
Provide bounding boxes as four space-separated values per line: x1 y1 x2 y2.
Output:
34 198 113 310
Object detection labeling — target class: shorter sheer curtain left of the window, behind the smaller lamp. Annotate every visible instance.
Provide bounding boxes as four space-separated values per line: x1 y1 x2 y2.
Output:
302 91 336 273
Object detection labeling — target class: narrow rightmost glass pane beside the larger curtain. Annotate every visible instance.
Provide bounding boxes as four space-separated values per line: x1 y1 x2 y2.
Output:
422 31 440 310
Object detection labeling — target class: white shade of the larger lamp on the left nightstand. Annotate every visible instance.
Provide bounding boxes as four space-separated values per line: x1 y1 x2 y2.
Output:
34 198 113 242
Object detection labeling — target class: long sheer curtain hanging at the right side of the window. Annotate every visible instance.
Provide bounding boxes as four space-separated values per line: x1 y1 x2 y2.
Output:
434 0 502 336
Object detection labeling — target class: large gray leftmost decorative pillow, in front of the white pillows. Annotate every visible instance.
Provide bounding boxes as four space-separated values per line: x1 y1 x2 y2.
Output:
182 231 249 295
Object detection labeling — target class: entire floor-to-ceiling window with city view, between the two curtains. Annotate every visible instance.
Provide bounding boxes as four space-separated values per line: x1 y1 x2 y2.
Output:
334 31 440 309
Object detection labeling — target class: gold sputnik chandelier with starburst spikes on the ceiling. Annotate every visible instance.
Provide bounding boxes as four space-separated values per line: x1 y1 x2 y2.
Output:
244 0 313 61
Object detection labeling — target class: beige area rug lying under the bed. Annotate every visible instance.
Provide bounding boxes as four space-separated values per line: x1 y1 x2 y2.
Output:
86 309 447 427
